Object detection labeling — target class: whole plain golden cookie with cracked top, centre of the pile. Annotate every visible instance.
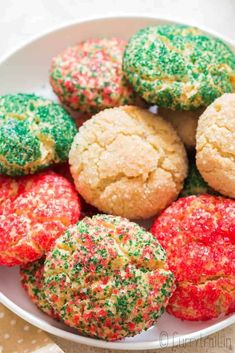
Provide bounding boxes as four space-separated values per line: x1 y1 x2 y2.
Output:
69 106 187 219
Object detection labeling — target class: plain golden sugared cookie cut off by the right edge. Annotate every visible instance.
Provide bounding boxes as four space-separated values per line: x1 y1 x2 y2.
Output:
196 93 235 198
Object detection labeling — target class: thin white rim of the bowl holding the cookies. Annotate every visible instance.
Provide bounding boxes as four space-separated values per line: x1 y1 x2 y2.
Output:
0 13 235 350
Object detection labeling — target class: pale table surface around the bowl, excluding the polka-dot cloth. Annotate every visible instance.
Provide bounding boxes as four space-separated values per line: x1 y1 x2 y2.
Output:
0 0 235 353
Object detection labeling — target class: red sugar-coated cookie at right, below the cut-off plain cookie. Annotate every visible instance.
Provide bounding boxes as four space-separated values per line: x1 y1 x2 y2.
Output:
151 195 235 320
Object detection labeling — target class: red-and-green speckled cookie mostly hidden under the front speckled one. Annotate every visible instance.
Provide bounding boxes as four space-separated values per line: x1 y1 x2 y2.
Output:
20 258 58 319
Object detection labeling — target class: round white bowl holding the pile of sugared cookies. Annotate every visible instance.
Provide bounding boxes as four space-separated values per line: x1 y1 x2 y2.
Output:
0 16 235 350
